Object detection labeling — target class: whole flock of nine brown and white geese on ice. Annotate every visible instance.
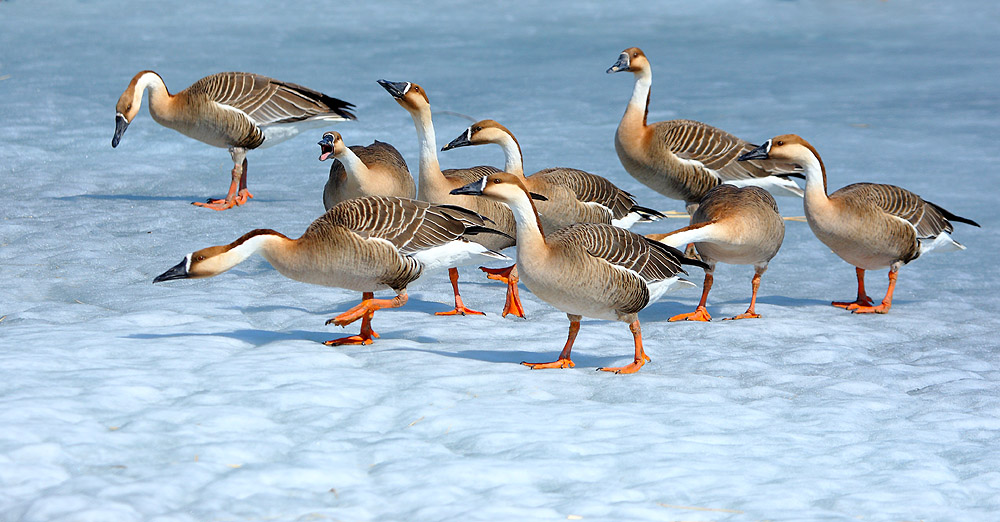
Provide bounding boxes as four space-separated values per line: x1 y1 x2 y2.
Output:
112 47 979 373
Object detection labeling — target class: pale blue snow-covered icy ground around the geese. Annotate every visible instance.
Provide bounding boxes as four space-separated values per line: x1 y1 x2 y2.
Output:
0 0 1000 521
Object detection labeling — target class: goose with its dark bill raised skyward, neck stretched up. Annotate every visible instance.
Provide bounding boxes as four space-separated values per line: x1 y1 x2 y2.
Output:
378 80 524 317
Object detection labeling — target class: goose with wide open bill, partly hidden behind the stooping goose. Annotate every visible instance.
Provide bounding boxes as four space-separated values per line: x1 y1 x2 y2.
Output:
319 131 417 209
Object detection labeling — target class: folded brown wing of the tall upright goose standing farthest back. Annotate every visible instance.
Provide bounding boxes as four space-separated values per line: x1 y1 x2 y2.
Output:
662 120 802 181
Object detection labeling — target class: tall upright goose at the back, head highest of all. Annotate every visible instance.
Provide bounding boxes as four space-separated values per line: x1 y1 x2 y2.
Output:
607 47 802 214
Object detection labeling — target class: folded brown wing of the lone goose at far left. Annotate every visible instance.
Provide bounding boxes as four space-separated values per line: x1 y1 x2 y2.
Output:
189 72 355 125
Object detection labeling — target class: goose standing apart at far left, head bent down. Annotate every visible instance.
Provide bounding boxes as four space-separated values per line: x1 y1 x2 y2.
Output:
111 71 355 210
